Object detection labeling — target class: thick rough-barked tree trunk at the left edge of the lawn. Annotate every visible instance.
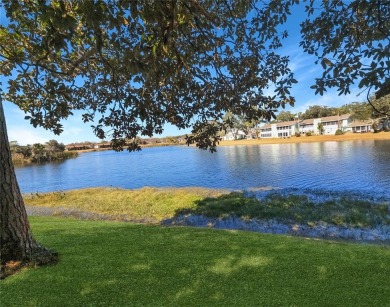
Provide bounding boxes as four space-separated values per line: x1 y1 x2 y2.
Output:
0 96 57 278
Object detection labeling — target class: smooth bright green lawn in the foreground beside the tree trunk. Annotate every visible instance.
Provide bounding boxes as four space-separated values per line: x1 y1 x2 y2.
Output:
0 217 390 307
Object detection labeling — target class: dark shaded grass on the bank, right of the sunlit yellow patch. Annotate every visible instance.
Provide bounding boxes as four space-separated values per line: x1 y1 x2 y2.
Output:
170 192 390 227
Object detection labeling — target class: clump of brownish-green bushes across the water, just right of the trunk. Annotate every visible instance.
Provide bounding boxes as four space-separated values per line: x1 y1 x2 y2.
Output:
10 140 77 163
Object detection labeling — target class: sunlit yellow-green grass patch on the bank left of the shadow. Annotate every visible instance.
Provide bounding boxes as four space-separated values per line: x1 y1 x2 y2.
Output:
24 187 226 222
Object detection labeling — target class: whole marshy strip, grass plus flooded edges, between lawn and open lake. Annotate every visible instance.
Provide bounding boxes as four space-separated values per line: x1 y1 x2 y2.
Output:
25 187 390 245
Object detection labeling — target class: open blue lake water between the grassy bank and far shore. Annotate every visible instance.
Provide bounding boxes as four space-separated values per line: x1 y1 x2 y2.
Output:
16 141 390 199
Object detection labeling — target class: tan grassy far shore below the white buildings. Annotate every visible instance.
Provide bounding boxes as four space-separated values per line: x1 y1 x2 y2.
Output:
219 132 390 146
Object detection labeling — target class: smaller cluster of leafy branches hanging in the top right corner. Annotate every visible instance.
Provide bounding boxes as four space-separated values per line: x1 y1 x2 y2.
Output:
301 0 390 101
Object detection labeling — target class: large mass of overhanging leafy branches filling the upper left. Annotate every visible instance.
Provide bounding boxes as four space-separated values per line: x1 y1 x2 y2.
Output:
0 0 296 150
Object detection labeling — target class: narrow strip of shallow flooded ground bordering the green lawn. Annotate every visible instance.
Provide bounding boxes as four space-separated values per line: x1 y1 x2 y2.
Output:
26 205 390 246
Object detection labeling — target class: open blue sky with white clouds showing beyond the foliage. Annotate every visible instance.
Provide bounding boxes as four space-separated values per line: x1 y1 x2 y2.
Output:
0 3 365 145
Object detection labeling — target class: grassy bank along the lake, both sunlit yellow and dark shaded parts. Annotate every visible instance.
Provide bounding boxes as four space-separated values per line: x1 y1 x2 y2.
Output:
25 188 390 227
